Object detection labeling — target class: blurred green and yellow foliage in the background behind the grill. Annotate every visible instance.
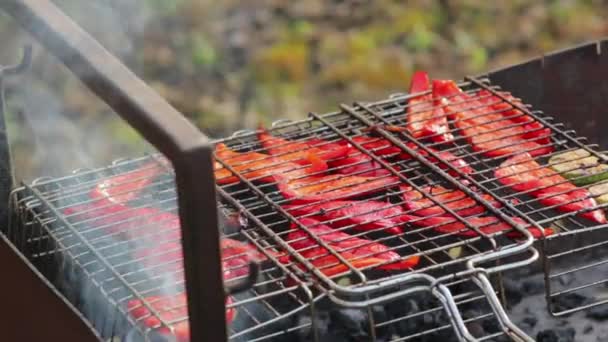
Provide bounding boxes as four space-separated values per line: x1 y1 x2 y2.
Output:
0 0 608 180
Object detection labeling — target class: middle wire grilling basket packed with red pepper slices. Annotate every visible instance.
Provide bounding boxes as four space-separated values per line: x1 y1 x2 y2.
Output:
216 78 530 302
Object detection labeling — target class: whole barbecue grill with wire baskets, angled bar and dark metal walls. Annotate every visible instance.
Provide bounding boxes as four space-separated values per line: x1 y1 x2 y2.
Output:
0 0 608 341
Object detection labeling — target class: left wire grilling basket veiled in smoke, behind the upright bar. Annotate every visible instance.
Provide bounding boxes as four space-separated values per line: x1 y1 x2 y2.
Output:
6 157 313 341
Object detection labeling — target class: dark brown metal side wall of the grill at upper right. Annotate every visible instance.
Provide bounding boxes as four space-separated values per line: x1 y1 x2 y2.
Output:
488 40 608 149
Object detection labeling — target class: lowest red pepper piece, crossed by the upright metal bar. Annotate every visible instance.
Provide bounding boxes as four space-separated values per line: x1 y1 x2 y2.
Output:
127 293 236 342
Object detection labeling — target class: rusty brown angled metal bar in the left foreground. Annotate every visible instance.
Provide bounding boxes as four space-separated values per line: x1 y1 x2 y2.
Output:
0 0 227 341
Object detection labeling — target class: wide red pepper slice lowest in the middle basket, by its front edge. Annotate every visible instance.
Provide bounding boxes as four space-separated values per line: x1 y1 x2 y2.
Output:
283 218 420 276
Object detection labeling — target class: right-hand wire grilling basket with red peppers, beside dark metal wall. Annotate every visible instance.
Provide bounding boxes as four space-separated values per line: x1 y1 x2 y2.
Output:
357 78 608 315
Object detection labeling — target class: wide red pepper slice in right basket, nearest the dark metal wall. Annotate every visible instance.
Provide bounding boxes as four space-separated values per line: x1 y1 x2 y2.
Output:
433 80 553 157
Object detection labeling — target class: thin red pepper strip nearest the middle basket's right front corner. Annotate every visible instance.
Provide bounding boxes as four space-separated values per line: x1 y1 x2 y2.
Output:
410 216 553 238
